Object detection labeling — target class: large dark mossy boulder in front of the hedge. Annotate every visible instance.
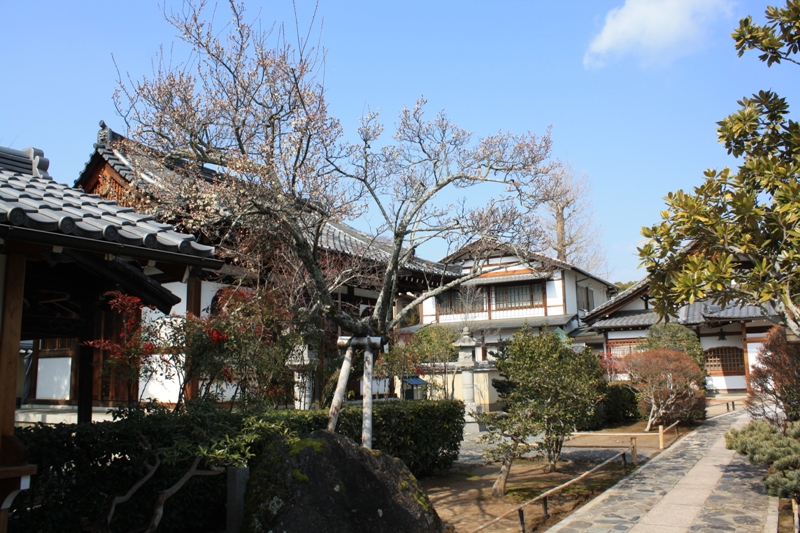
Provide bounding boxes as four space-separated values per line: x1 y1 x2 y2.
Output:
243 431 442 533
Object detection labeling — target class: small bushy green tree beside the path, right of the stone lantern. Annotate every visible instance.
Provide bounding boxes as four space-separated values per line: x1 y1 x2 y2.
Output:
480 327 602 496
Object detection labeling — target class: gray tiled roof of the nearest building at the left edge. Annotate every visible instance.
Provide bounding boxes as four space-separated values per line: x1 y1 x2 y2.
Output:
0 147 214 258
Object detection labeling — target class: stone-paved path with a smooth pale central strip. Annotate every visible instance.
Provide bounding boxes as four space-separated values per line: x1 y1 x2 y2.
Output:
548 411 778 533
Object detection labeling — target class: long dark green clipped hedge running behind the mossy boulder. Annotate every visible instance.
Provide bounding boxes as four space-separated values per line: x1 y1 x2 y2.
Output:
9 401 464 533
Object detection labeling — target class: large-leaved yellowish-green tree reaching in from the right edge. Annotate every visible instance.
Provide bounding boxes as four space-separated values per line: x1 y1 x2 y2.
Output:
639 0 800 334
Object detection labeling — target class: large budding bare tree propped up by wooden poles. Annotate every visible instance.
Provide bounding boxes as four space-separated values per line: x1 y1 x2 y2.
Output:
115 0 552 440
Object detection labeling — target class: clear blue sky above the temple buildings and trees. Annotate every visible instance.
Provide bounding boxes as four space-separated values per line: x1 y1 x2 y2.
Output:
0 0 798 281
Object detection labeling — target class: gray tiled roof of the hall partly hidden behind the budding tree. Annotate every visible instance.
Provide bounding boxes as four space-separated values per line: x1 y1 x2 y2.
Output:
75 121 461 278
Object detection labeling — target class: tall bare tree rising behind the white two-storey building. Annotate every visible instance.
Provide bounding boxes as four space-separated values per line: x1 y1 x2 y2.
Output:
542 163 606 272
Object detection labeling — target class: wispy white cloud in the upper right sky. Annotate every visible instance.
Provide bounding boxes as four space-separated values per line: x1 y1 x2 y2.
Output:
583 0 731 68
